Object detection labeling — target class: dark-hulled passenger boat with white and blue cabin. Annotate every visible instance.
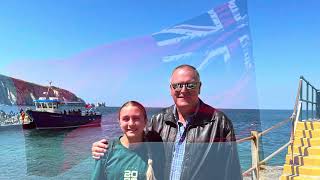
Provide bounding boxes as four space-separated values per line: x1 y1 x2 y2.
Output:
23 84 101 129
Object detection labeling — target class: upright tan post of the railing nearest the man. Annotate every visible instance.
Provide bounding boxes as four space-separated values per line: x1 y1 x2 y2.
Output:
251 131 260 180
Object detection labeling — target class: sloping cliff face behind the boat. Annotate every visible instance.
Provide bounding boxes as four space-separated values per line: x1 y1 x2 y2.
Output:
0 74 84 106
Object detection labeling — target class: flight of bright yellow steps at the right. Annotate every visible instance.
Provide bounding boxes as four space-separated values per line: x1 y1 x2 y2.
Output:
279 121 320 180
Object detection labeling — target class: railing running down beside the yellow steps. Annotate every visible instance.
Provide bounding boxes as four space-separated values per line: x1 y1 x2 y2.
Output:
237 76 320 179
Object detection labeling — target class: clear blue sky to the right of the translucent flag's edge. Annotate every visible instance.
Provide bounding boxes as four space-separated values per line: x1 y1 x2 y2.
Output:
248 0 320 109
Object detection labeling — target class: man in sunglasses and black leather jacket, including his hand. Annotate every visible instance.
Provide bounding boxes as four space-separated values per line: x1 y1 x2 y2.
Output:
92 65 242 180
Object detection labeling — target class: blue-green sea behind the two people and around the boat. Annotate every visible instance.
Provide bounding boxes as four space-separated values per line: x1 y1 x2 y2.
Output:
0 106 292 180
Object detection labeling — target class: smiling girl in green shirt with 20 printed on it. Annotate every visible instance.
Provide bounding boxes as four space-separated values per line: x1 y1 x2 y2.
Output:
92 101 163 180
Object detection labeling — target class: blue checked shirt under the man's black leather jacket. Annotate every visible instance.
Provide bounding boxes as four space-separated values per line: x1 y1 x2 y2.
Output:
170 105 199 180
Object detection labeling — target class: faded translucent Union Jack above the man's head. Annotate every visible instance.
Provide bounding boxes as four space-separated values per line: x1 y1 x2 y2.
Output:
152 0 253 70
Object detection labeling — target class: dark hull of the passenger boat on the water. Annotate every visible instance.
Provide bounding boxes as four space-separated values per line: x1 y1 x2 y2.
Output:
26 110 101 129
